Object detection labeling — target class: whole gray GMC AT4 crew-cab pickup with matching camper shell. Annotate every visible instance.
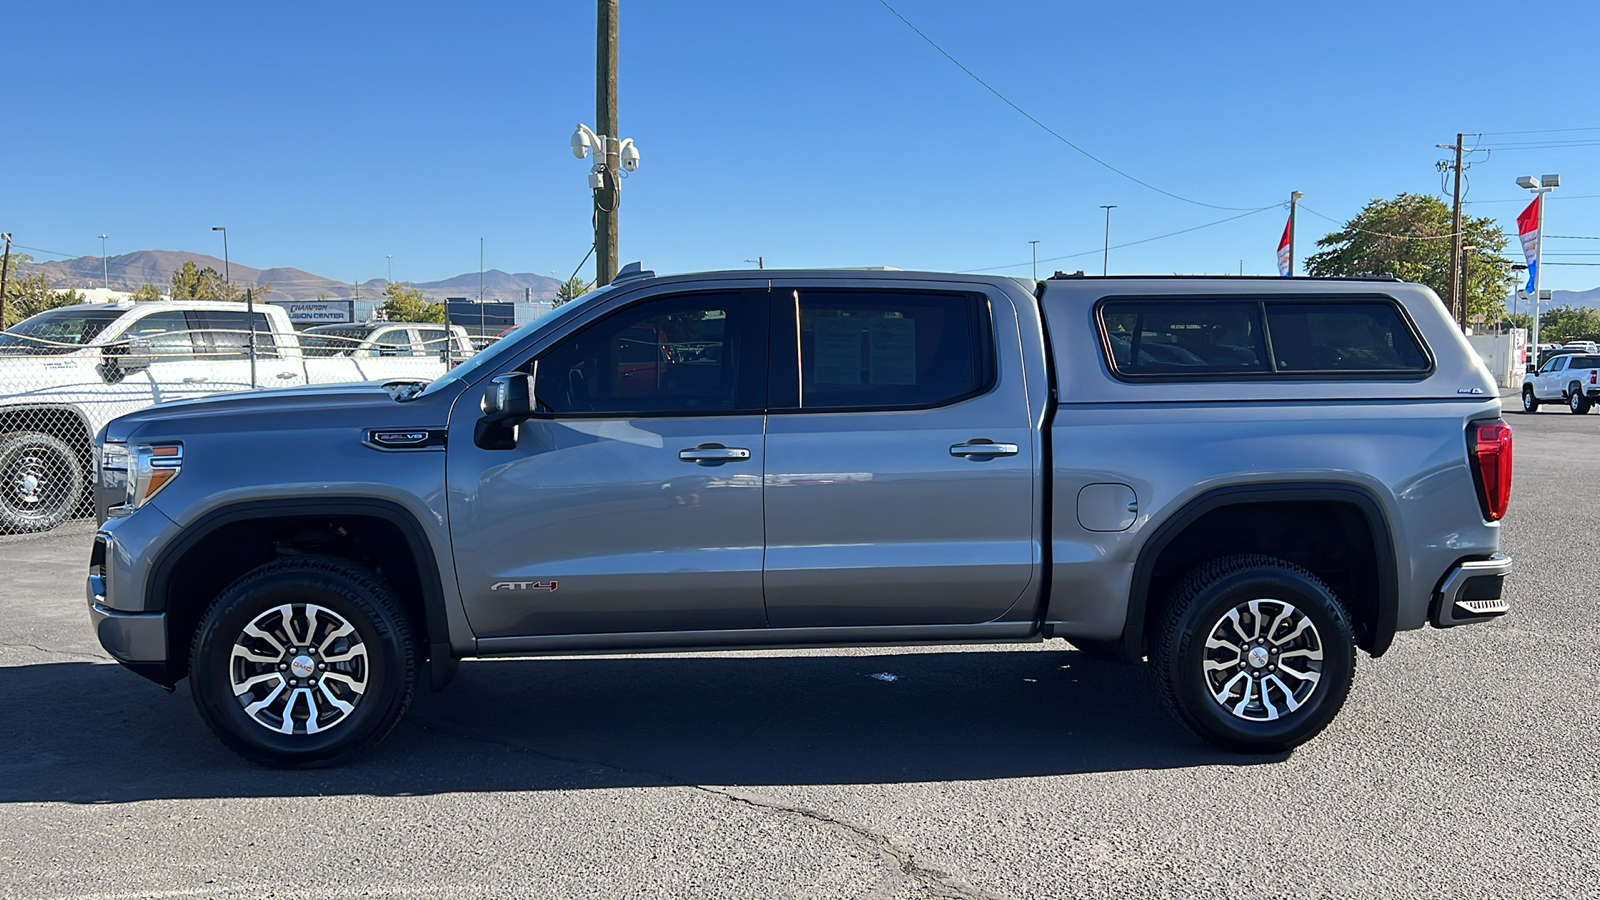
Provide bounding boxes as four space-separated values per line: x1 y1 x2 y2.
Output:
88 269 1512 765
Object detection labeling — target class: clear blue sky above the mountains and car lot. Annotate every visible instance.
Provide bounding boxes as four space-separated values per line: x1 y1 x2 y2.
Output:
12 0 1600 290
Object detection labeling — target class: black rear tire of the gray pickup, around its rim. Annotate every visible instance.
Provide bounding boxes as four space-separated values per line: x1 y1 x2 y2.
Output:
1152 554 1355 753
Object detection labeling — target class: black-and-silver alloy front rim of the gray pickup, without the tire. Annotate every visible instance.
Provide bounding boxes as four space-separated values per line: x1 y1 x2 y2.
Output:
229 604 371 735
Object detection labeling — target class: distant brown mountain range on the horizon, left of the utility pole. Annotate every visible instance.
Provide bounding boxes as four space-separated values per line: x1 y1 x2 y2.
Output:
30 250 562 299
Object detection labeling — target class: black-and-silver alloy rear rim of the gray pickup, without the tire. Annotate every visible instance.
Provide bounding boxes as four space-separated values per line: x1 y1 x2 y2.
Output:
1203 599 1323 722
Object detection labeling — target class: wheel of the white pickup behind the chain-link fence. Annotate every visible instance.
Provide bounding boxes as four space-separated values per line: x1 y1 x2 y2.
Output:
0 431 85 533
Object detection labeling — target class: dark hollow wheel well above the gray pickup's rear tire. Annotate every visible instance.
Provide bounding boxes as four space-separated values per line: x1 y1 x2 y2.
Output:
1141 500 1394 655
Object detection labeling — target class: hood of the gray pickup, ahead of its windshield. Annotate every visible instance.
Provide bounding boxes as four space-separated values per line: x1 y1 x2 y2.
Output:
106 381 450 440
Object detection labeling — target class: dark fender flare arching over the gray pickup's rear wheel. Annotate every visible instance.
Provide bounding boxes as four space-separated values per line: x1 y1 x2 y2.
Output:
1122 482 1400 660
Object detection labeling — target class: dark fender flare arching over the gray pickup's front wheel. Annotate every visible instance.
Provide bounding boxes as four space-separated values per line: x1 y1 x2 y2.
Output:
144 496 459 690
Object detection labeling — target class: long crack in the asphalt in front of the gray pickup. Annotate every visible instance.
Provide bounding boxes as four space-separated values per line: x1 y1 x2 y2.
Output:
418 719 998 900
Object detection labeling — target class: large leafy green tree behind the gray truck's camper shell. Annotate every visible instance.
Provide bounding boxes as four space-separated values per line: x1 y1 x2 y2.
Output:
1306 194 1512 323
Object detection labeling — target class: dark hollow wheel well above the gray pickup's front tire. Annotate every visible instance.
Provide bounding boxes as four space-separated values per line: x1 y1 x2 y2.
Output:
155 514 443 682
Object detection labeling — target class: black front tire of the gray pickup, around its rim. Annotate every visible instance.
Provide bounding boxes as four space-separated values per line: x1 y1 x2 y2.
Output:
189 556 418 767
